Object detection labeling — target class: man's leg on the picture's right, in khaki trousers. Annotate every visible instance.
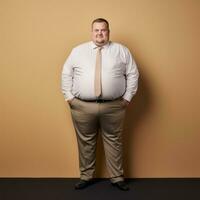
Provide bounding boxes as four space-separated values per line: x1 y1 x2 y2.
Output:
100 100 125 183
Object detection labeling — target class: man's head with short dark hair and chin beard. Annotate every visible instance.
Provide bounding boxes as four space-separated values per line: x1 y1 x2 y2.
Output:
92 18 110 46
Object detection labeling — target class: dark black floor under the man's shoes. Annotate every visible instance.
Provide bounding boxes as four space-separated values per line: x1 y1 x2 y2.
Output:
0 178 200 200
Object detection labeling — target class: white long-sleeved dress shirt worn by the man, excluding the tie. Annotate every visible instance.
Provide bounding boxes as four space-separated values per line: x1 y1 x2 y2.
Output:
62 41 139 101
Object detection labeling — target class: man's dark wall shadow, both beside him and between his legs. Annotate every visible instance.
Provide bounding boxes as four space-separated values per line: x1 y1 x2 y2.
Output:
96 63 153 177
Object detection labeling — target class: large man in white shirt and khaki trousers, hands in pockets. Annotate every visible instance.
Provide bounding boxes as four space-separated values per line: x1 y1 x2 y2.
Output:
62 18 139 190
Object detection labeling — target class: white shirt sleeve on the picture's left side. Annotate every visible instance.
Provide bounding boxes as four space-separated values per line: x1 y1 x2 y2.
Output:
61 50 74 101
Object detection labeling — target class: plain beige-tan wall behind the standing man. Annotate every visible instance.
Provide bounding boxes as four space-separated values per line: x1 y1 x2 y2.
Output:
0 0 200 177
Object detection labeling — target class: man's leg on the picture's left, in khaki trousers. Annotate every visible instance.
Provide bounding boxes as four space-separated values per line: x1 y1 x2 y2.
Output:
71 99 98 180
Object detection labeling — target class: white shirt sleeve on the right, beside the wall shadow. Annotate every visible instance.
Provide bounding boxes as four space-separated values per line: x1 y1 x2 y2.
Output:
123 48 139 102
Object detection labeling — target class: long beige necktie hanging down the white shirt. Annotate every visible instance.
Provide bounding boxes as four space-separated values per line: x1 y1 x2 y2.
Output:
94 47 102 97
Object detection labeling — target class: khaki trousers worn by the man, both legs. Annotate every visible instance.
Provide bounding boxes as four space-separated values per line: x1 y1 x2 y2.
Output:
70 98 125 183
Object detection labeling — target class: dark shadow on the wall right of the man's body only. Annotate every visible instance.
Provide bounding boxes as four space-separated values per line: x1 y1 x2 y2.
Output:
123 67 154 177
